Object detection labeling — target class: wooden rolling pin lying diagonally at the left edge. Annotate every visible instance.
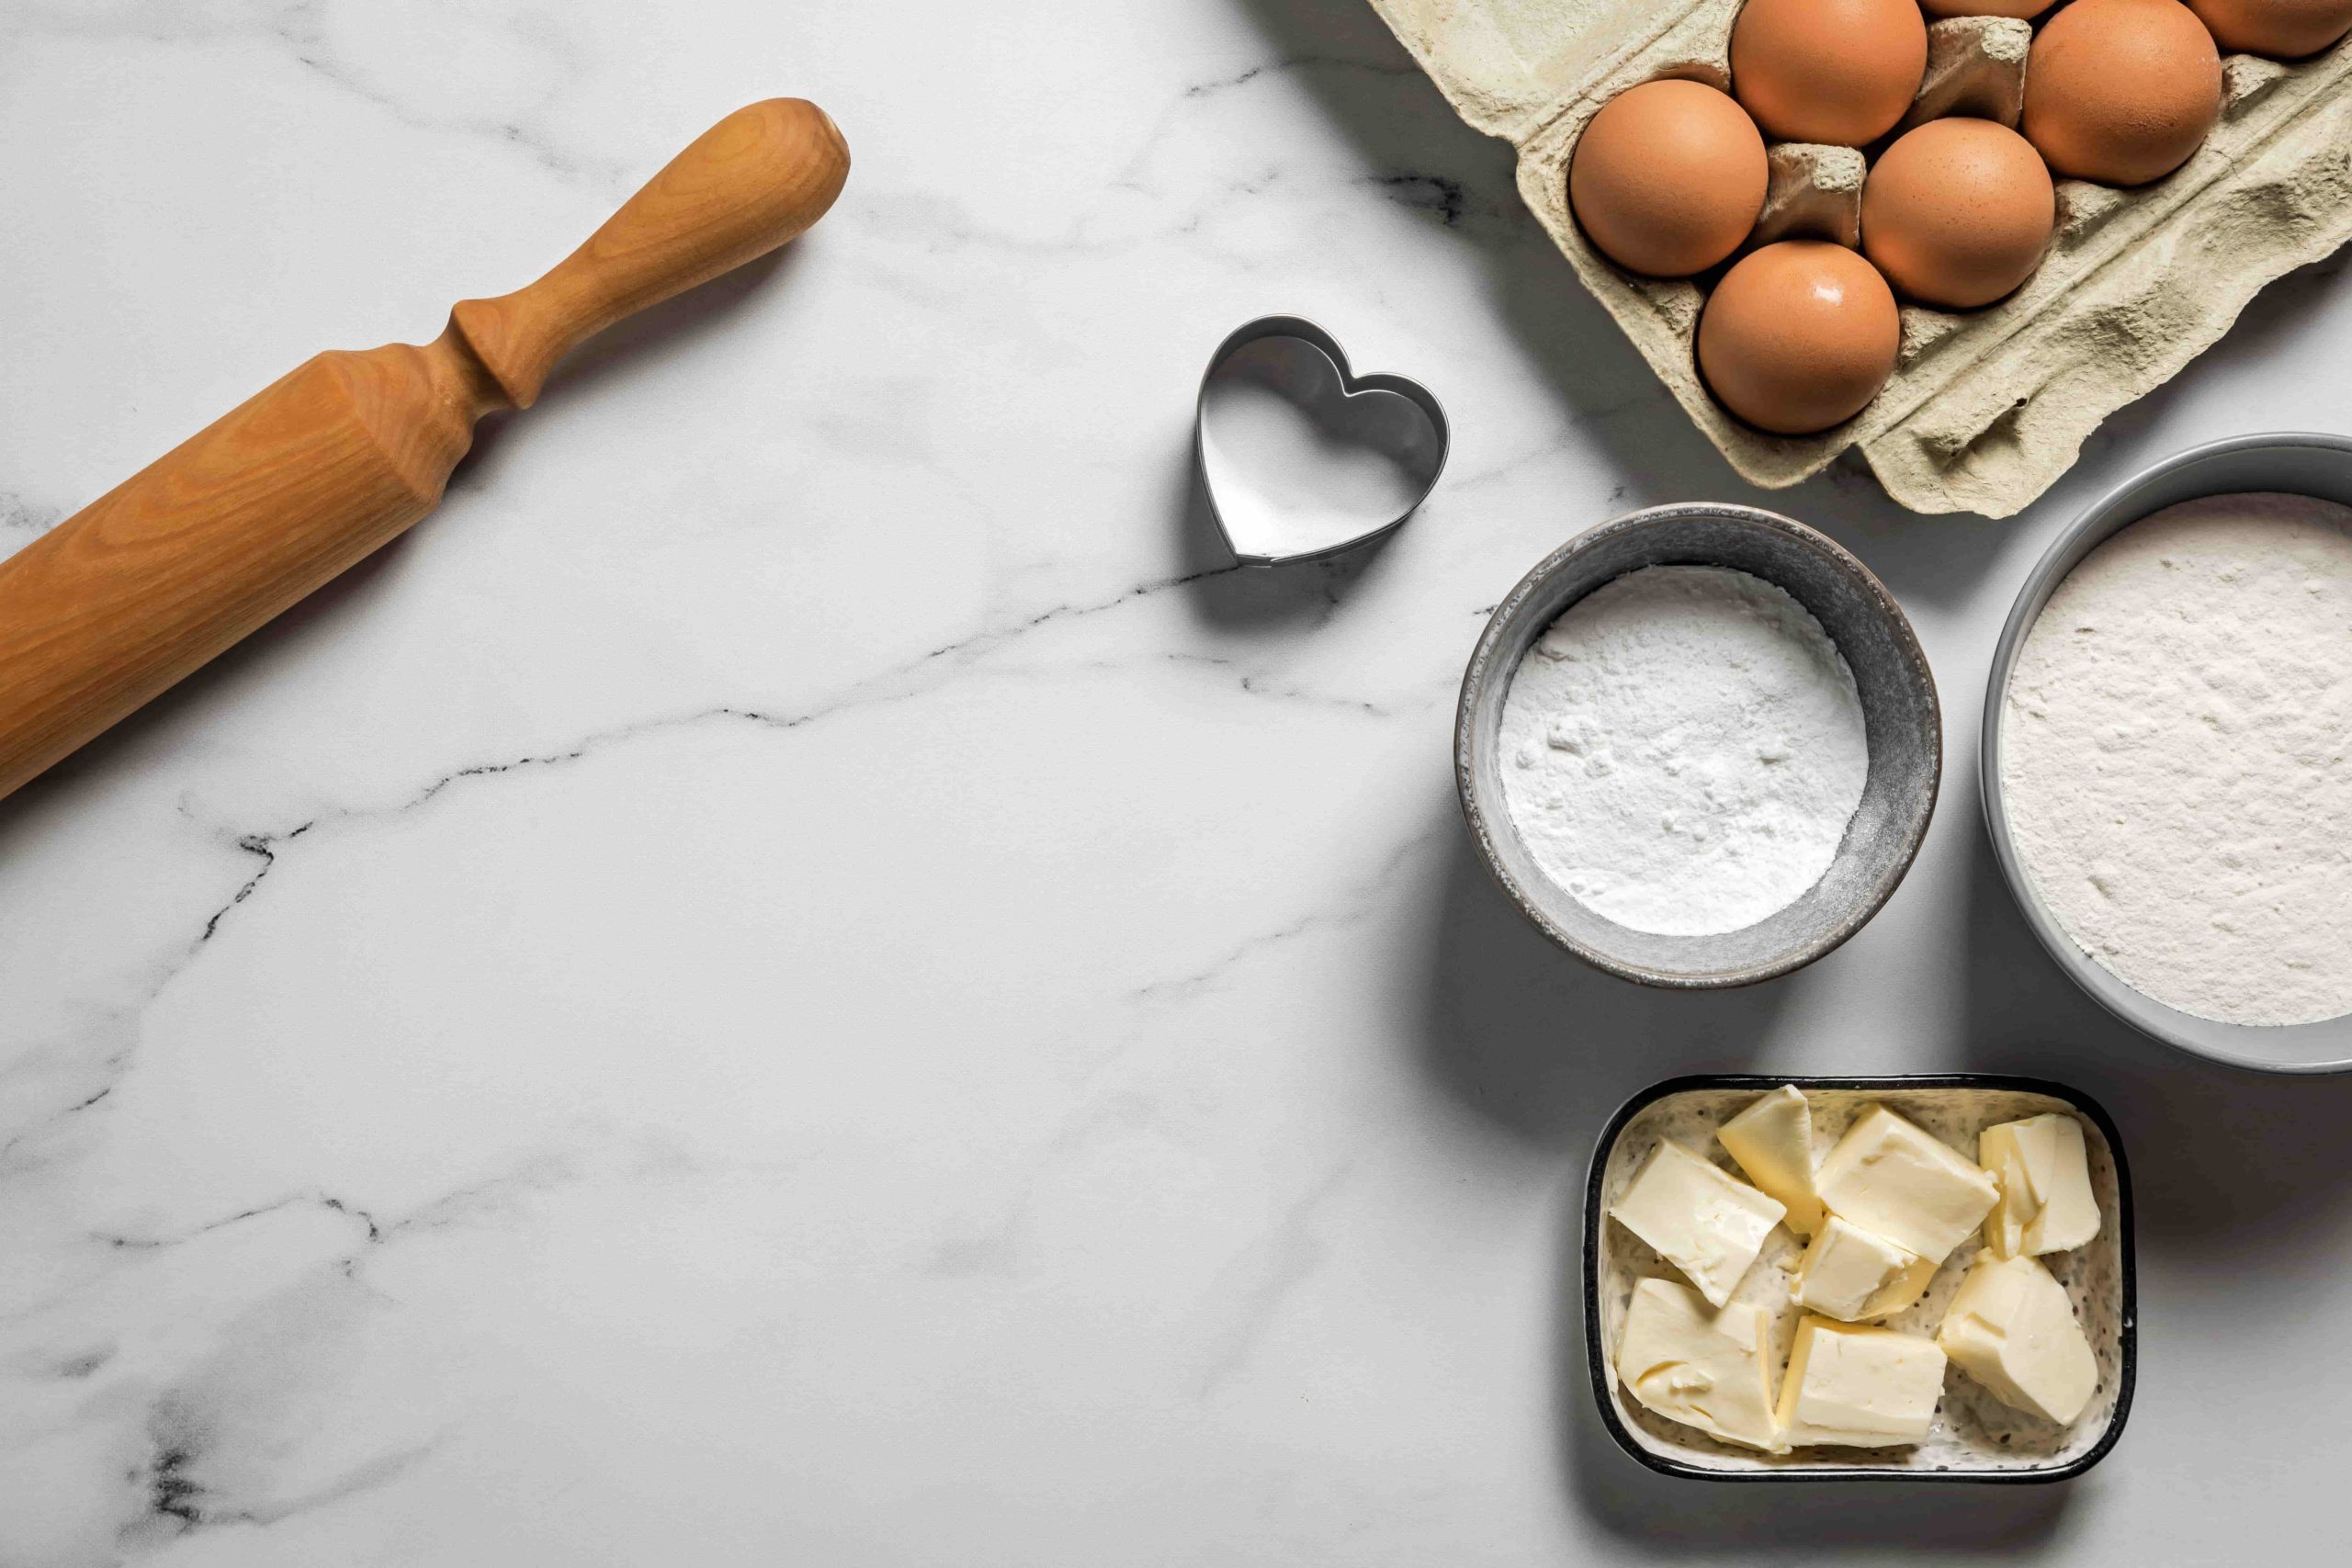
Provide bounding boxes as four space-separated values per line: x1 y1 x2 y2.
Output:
0 98 849 795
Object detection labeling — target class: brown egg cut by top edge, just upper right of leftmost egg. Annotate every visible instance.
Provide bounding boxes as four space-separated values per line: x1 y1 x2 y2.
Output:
1731 0 1927 148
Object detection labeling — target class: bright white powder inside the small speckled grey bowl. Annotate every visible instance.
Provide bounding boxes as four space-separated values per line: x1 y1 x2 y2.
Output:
1503 567 1870 936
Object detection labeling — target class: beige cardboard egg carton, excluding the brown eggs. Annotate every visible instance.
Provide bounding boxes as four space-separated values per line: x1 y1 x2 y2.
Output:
1371 0 2352 517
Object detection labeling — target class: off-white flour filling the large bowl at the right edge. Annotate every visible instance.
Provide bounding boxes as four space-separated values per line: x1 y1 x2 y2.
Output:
2002 493 2352 1025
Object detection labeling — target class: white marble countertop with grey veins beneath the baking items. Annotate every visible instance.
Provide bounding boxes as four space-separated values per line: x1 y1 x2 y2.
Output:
0 0 2352 1568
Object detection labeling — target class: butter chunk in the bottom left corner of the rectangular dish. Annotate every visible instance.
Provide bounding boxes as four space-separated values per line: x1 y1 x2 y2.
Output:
1618 1279 1785 1453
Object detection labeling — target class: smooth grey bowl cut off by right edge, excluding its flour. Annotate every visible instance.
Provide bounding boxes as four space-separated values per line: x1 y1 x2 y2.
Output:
1978 433 2352 1072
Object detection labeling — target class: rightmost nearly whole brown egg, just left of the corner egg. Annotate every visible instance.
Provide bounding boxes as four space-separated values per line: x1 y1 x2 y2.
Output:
2018 0 2221 186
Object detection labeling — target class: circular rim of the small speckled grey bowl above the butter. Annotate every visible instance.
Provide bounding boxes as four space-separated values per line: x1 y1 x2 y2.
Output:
1453 501 1945 989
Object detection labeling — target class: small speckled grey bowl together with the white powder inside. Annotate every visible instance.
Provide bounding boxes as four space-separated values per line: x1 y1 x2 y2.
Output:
1453 503 1943 987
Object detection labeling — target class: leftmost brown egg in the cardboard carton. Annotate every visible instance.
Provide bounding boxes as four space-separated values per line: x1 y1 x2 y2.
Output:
1569 83 1771 277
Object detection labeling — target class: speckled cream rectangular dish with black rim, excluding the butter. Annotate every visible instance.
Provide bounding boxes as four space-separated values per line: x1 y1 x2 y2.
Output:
1583 1072 2138 1483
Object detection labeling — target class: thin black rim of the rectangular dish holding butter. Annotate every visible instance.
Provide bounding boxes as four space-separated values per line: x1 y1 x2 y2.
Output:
1583 1072 2141 1485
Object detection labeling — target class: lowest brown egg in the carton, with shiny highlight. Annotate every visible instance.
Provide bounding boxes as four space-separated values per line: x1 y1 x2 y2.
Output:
1698 240 1903 434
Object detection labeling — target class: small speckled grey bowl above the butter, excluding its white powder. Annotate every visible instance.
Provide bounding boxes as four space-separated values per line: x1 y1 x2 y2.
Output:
1453 503 1943 989
